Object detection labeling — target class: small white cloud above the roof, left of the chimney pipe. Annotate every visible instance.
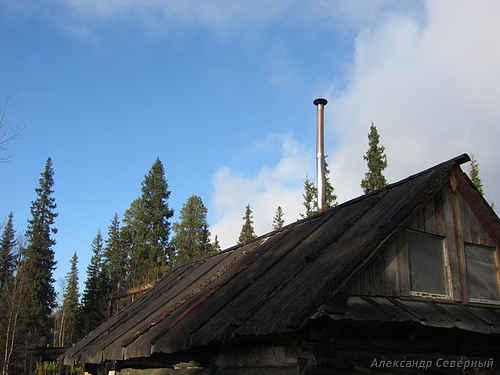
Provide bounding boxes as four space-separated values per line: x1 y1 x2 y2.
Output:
209 134 311 248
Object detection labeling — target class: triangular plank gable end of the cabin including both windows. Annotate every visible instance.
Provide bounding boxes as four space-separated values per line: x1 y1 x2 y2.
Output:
344 174 500 306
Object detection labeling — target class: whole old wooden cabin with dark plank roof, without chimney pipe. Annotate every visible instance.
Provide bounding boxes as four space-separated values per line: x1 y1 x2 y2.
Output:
61 154 500 375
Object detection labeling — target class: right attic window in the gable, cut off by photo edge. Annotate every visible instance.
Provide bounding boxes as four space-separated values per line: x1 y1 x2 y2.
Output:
465 244 500 302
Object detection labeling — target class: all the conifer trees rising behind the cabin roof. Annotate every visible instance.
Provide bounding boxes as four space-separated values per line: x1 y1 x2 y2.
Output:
0 123 488 375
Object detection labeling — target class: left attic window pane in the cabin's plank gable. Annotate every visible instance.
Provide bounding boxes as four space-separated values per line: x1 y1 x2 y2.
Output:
406 231 448 297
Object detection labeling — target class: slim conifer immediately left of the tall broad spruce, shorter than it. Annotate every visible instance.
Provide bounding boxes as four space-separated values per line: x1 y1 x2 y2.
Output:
102 213 128 292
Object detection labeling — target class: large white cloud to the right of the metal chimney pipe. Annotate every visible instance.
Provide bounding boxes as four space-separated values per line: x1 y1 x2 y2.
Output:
327 1 500 206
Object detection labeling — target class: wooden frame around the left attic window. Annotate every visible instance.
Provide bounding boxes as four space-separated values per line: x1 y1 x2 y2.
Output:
405 228 453 301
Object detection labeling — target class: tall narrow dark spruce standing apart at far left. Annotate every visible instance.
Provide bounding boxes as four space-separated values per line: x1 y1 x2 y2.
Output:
24 158 57 346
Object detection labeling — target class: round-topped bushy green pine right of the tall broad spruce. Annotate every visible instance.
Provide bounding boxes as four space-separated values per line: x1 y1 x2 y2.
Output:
172 195 215 264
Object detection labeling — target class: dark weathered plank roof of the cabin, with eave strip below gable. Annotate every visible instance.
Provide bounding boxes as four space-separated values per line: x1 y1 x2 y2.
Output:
64 154 500 364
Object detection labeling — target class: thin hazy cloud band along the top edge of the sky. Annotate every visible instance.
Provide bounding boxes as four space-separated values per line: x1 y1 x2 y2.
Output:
16 0 421 42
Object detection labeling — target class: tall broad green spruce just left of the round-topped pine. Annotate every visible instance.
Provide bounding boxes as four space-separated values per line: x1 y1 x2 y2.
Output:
124 158 174 285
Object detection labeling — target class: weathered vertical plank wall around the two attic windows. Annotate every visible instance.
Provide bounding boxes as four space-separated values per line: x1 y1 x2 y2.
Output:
347 184 498 302
